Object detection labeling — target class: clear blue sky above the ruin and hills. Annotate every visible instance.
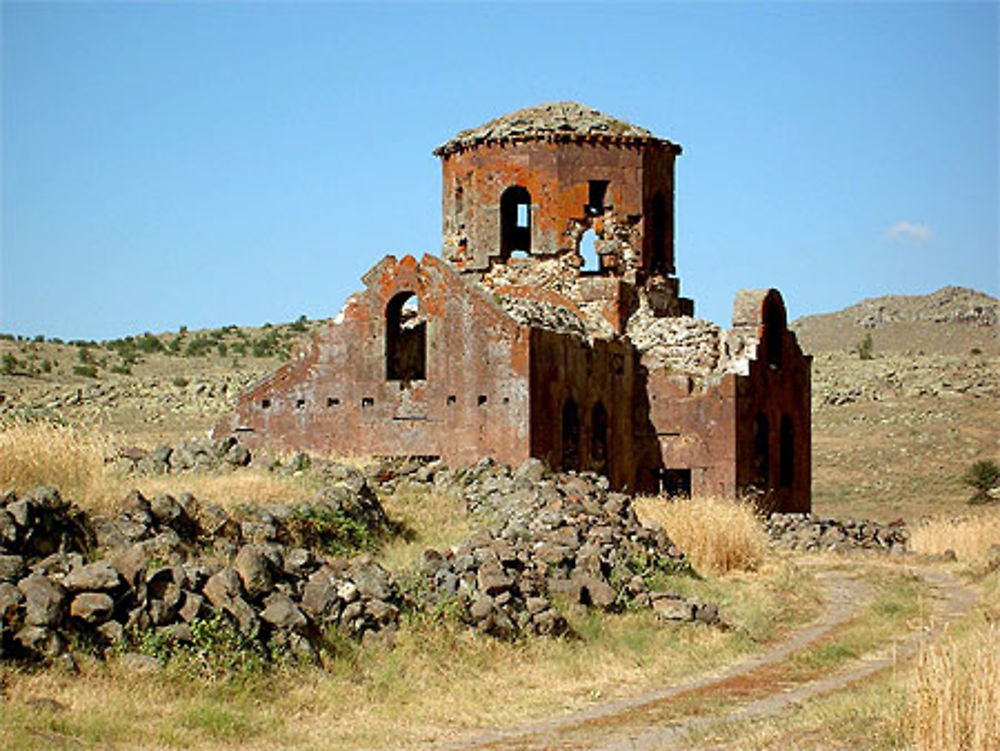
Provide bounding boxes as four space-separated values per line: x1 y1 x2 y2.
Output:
0 2 1000 339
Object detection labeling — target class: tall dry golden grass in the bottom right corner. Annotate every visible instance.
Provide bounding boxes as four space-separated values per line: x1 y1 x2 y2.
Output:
908 624 1000 751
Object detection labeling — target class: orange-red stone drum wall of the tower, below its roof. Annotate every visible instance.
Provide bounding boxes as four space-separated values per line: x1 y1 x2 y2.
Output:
441 140 677 272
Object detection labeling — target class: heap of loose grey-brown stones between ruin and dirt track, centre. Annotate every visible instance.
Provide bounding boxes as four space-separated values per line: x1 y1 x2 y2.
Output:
398 459 719 638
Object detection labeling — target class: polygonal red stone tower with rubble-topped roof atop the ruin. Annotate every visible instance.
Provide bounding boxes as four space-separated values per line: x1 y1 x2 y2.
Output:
434 102 681 286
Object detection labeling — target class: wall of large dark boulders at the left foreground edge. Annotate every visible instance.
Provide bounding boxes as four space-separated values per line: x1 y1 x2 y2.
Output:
0 473 402 658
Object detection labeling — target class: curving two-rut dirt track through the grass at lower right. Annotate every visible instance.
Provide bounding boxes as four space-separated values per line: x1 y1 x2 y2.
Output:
430 570 978 751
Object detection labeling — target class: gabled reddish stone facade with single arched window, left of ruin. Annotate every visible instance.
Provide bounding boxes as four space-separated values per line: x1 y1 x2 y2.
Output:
216 256 530 464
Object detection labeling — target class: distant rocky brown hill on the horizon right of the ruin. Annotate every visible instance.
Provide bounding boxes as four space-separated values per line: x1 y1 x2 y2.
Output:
791 287 1000 355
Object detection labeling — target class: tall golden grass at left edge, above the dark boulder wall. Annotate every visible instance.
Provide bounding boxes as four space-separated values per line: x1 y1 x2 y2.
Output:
0 421 109 498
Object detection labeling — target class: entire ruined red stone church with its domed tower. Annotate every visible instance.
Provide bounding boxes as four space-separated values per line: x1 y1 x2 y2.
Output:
216 102 811 511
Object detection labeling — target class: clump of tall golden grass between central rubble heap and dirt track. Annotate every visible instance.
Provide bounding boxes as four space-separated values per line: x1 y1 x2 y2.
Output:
635 496 768 574
